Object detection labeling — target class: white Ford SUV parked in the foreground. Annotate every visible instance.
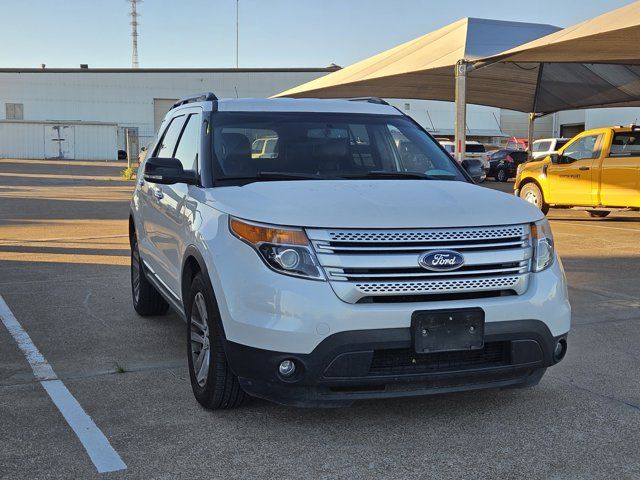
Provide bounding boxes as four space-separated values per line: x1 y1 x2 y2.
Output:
129 94 571 408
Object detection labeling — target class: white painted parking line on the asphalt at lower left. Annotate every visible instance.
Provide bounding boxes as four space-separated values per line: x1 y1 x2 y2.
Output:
0 296 127 473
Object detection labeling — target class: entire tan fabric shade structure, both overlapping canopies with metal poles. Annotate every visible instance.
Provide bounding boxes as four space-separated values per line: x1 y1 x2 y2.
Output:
279 2 640 159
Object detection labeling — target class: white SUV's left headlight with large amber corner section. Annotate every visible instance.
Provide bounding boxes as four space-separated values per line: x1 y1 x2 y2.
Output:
229 217 325 280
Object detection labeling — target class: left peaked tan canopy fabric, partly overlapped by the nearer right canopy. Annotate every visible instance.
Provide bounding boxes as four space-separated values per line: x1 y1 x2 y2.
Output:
276 18 559 111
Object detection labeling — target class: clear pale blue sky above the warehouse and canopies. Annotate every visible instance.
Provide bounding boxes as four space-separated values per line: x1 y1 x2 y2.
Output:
0 0 632 68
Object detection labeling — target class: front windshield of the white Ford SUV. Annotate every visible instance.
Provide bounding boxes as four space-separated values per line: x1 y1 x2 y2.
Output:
212 112 466 184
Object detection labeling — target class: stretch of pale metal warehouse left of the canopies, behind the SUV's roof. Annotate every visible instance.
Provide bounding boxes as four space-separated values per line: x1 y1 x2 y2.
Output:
0 67 336 160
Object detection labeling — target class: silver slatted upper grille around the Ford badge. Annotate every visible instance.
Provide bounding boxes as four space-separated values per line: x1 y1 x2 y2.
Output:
307 225 533 303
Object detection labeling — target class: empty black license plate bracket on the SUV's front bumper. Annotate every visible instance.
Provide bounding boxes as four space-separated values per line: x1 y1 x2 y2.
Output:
411 307 484 353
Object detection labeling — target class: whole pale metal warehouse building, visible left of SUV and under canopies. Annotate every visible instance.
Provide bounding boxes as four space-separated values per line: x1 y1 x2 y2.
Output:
0 65 640 160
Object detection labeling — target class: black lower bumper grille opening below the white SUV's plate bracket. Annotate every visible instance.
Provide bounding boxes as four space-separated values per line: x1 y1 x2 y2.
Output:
369 342 511 375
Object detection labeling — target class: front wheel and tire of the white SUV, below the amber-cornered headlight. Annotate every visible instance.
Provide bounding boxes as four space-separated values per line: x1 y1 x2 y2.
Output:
185 273 247 410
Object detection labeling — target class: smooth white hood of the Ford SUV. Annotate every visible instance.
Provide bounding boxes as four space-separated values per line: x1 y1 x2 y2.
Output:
205 180 544 228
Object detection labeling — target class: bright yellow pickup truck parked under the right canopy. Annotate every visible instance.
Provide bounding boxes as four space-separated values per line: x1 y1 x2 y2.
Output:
514 125 640 217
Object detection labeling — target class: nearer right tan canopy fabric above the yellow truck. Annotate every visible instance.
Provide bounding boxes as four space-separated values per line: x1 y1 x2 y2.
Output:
480 2 640 113
